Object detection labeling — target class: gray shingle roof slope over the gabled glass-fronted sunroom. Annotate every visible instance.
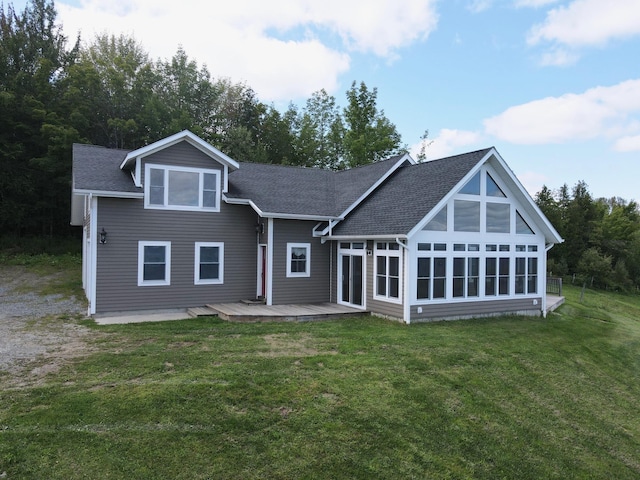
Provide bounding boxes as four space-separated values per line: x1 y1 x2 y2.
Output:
333 148 491 236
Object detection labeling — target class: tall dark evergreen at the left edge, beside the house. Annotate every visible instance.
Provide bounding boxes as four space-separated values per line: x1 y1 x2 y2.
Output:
0 0 78 236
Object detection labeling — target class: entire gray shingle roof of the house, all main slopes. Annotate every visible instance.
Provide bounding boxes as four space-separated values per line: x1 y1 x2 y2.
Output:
73 138 490 236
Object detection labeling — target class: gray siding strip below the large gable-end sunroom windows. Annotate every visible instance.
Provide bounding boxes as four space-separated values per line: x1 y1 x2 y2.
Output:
411 297 542 322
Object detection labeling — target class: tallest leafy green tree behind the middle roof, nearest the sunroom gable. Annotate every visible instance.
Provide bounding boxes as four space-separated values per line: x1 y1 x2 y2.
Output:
343 82 401 167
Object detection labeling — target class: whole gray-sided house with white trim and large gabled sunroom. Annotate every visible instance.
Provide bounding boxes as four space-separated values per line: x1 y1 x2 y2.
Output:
71 131 562 323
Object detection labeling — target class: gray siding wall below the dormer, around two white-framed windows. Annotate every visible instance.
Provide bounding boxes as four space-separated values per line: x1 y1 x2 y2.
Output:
96 198 257 313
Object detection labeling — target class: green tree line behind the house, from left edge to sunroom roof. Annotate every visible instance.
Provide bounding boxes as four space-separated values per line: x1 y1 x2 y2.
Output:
0 0 406 236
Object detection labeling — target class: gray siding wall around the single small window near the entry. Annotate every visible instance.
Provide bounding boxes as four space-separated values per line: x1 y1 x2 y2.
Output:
272 220 331 304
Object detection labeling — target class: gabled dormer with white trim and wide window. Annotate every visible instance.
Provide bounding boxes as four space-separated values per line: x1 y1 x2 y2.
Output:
120 130 239 212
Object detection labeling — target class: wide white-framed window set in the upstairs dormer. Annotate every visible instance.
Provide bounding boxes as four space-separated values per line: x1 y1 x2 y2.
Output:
145 164 220 212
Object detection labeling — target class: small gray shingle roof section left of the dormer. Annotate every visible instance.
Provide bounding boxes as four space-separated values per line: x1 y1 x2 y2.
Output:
73 143 142 193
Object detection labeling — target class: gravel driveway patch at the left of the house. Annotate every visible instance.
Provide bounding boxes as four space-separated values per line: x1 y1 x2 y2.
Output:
0 266 91 384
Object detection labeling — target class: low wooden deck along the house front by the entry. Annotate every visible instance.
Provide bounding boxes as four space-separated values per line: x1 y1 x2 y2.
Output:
189 302 369 322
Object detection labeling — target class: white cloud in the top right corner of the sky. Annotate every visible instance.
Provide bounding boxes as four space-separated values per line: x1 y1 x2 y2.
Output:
521 0 640 47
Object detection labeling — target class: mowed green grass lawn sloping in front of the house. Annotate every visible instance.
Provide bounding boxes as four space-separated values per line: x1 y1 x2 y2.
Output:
0 280 640 479
